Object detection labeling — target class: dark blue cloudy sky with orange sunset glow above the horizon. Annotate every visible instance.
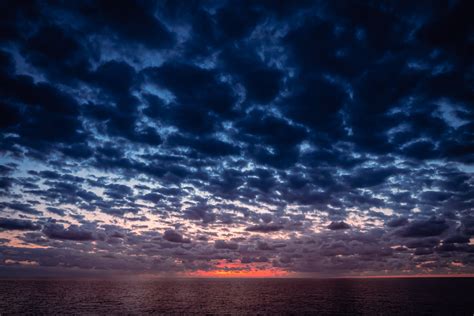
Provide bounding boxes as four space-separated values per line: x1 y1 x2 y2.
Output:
0 0 474 277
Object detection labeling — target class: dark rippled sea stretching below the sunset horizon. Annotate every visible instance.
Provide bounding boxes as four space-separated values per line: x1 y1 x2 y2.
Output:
0 278 474 316
